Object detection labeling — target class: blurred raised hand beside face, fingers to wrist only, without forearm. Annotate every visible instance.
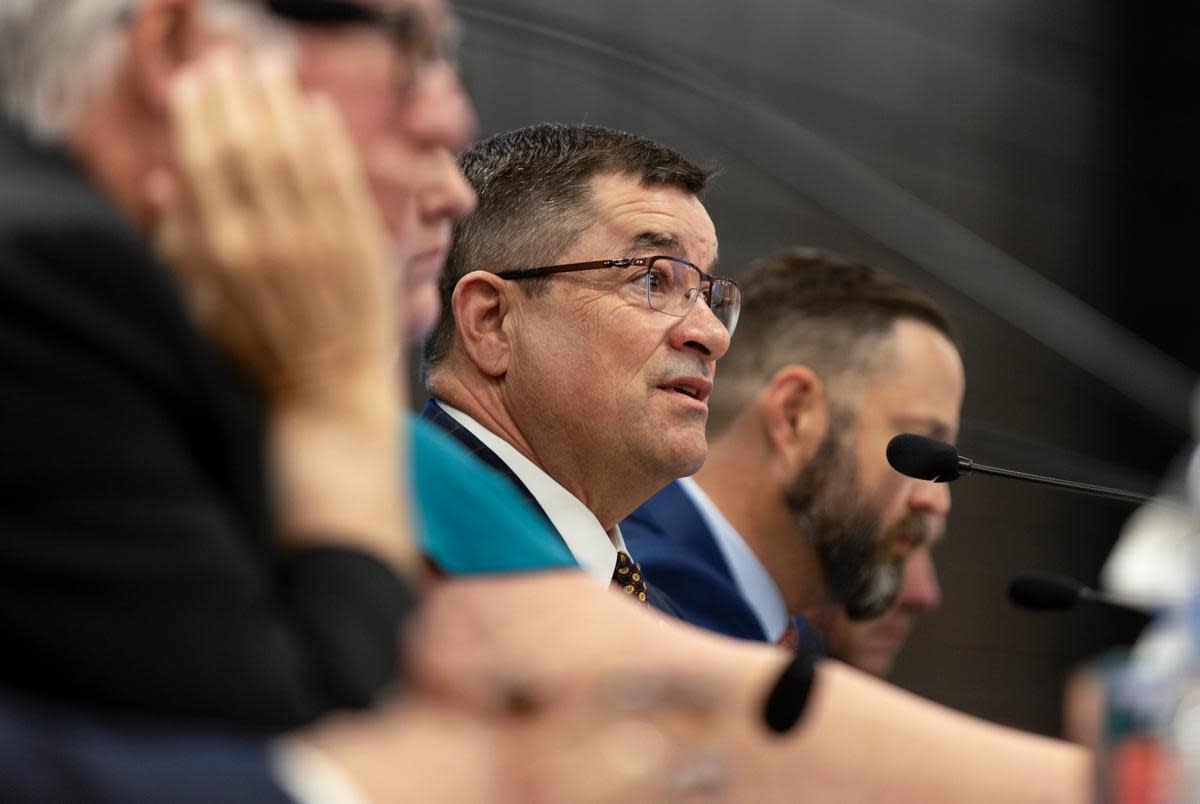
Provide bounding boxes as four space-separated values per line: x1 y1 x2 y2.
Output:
157 52 396 406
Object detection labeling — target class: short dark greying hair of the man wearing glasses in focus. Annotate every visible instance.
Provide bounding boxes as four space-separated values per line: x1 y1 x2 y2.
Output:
422 122 712 379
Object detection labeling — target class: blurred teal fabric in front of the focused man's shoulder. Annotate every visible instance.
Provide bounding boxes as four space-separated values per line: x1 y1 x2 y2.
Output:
407 416 578 575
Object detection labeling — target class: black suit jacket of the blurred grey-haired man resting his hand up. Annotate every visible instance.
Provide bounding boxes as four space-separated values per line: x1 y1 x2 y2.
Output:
0 125 408 727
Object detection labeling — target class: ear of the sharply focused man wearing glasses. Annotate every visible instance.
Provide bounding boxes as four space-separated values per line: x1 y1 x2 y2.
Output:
450 271 511 377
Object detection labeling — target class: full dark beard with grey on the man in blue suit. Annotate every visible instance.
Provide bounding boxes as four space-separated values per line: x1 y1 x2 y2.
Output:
784 422 902 620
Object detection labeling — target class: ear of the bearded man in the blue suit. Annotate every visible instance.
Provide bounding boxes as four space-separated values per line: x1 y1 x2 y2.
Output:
757 365 829 472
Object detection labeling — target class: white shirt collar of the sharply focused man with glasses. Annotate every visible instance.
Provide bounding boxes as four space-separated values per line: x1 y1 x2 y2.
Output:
436 400 629 584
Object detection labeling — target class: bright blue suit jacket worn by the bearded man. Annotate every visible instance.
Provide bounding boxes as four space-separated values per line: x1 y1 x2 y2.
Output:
620 481 822 653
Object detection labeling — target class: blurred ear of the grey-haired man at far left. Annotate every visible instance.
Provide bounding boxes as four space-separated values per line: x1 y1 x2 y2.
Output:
128 0 204 115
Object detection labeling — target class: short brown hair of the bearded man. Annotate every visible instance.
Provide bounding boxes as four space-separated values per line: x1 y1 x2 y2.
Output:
708 248 959 437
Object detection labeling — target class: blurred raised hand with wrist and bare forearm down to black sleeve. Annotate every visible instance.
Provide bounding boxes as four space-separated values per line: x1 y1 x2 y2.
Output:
157 52 415 570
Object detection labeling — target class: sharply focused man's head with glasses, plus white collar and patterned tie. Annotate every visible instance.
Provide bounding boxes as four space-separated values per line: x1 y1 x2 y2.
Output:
425 125 742 608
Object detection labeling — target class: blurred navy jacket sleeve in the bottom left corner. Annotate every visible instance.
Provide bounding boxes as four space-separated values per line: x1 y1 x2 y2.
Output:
0 690 292 804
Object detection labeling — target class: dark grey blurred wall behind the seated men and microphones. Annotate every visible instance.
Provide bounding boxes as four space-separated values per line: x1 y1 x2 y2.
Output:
424 0 1200 734
